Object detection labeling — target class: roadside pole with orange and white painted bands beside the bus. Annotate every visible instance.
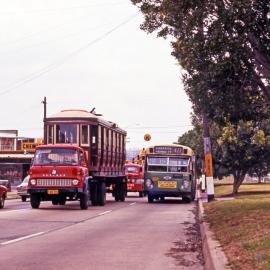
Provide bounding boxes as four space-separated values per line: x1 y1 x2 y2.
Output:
203 114 215 202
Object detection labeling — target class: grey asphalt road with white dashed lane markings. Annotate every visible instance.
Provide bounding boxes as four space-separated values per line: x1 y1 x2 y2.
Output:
0 193 203 270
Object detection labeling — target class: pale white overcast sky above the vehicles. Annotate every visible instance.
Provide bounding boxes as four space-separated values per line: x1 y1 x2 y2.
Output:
0 0 192 148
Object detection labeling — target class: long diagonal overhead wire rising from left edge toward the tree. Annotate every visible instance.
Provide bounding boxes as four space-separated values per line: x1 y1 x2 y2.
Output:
0 12 139 96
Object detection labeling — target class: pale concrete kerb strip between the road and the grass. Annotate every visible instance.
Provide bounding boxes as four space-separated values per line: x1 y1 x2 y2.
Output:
197 191 230 270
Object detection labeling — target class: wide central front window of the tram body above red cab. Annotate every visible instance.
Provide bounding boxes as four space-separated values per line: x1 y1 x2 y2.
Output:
56 124 78 143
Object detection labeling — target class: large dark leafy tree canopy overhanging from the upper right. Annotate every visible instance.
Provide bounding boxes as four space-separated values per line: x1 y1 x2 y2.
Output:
132 0 270 116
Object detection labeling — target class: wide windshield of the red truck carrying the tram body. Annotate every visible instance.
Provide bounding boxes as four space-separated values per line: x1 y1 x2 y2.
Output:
33 148 79 166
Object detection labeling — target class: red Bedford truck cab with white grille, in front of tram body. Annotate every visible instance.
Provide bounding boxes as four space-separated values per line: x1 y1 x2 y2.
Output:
28 144 89 209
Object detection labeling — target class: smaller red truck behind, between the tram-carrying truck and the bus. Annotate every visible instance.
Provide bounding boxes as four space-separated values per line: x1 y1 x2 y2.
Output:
125 163 144 197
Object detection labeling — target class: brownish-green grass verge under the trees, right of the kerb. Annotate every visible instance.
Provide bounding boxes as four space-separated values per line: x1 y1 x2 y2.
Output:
204 184 270 270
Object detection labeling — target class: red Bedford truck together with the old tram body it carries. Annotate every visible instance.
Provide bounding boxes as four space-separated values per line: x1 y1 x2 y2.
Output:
28 110 127 209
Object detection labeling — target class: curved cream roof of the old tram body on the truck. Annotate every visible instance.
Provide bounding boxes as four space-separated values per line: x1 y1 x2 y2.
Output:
46 109 126 134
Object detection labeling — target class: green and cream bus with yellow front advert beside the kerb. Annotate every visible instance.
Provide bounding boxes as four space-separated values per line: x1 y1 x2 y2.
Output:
138 144 196 203
